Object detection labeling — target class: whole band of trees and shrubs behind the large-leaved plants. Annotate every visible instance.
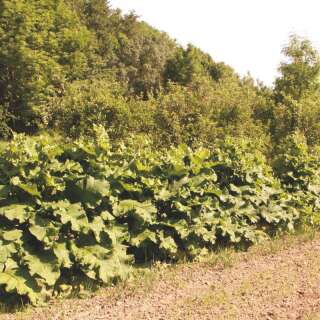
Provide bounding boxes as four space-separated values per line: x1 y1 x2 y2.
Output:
0 0 320 147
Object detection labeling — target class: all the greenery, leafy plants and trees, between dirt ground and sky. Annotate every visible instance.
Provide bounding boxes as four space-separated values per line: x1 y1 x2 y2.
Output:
0 0 320 304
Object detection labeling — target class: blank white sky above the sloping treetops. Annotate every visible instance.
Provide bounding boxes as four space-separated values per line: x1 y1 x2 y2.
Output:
110 0 320 85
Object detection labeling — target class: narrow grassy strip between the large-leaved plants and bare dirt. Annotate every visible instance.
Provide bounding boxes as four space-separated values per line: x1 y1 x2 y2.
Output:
0 227 320 320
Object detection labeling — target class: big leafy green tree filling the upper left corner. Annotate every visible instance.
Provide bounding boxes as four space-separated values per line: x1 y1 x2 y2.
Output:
0 0 94 132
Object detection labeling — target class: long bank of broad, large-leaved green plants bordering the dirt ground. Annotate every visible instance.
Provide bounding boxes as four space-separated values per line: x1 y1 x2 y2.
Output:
0 128 320 304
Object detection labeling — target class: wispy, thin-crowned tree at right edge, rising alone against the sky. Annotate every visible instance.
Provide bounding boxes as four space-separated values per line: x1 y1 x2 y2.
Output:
272 35 320 143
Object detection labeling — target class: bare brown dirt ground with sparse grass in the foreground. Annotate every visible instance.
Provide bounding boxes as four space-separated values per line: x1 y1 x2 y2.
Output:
0 236 320 320
